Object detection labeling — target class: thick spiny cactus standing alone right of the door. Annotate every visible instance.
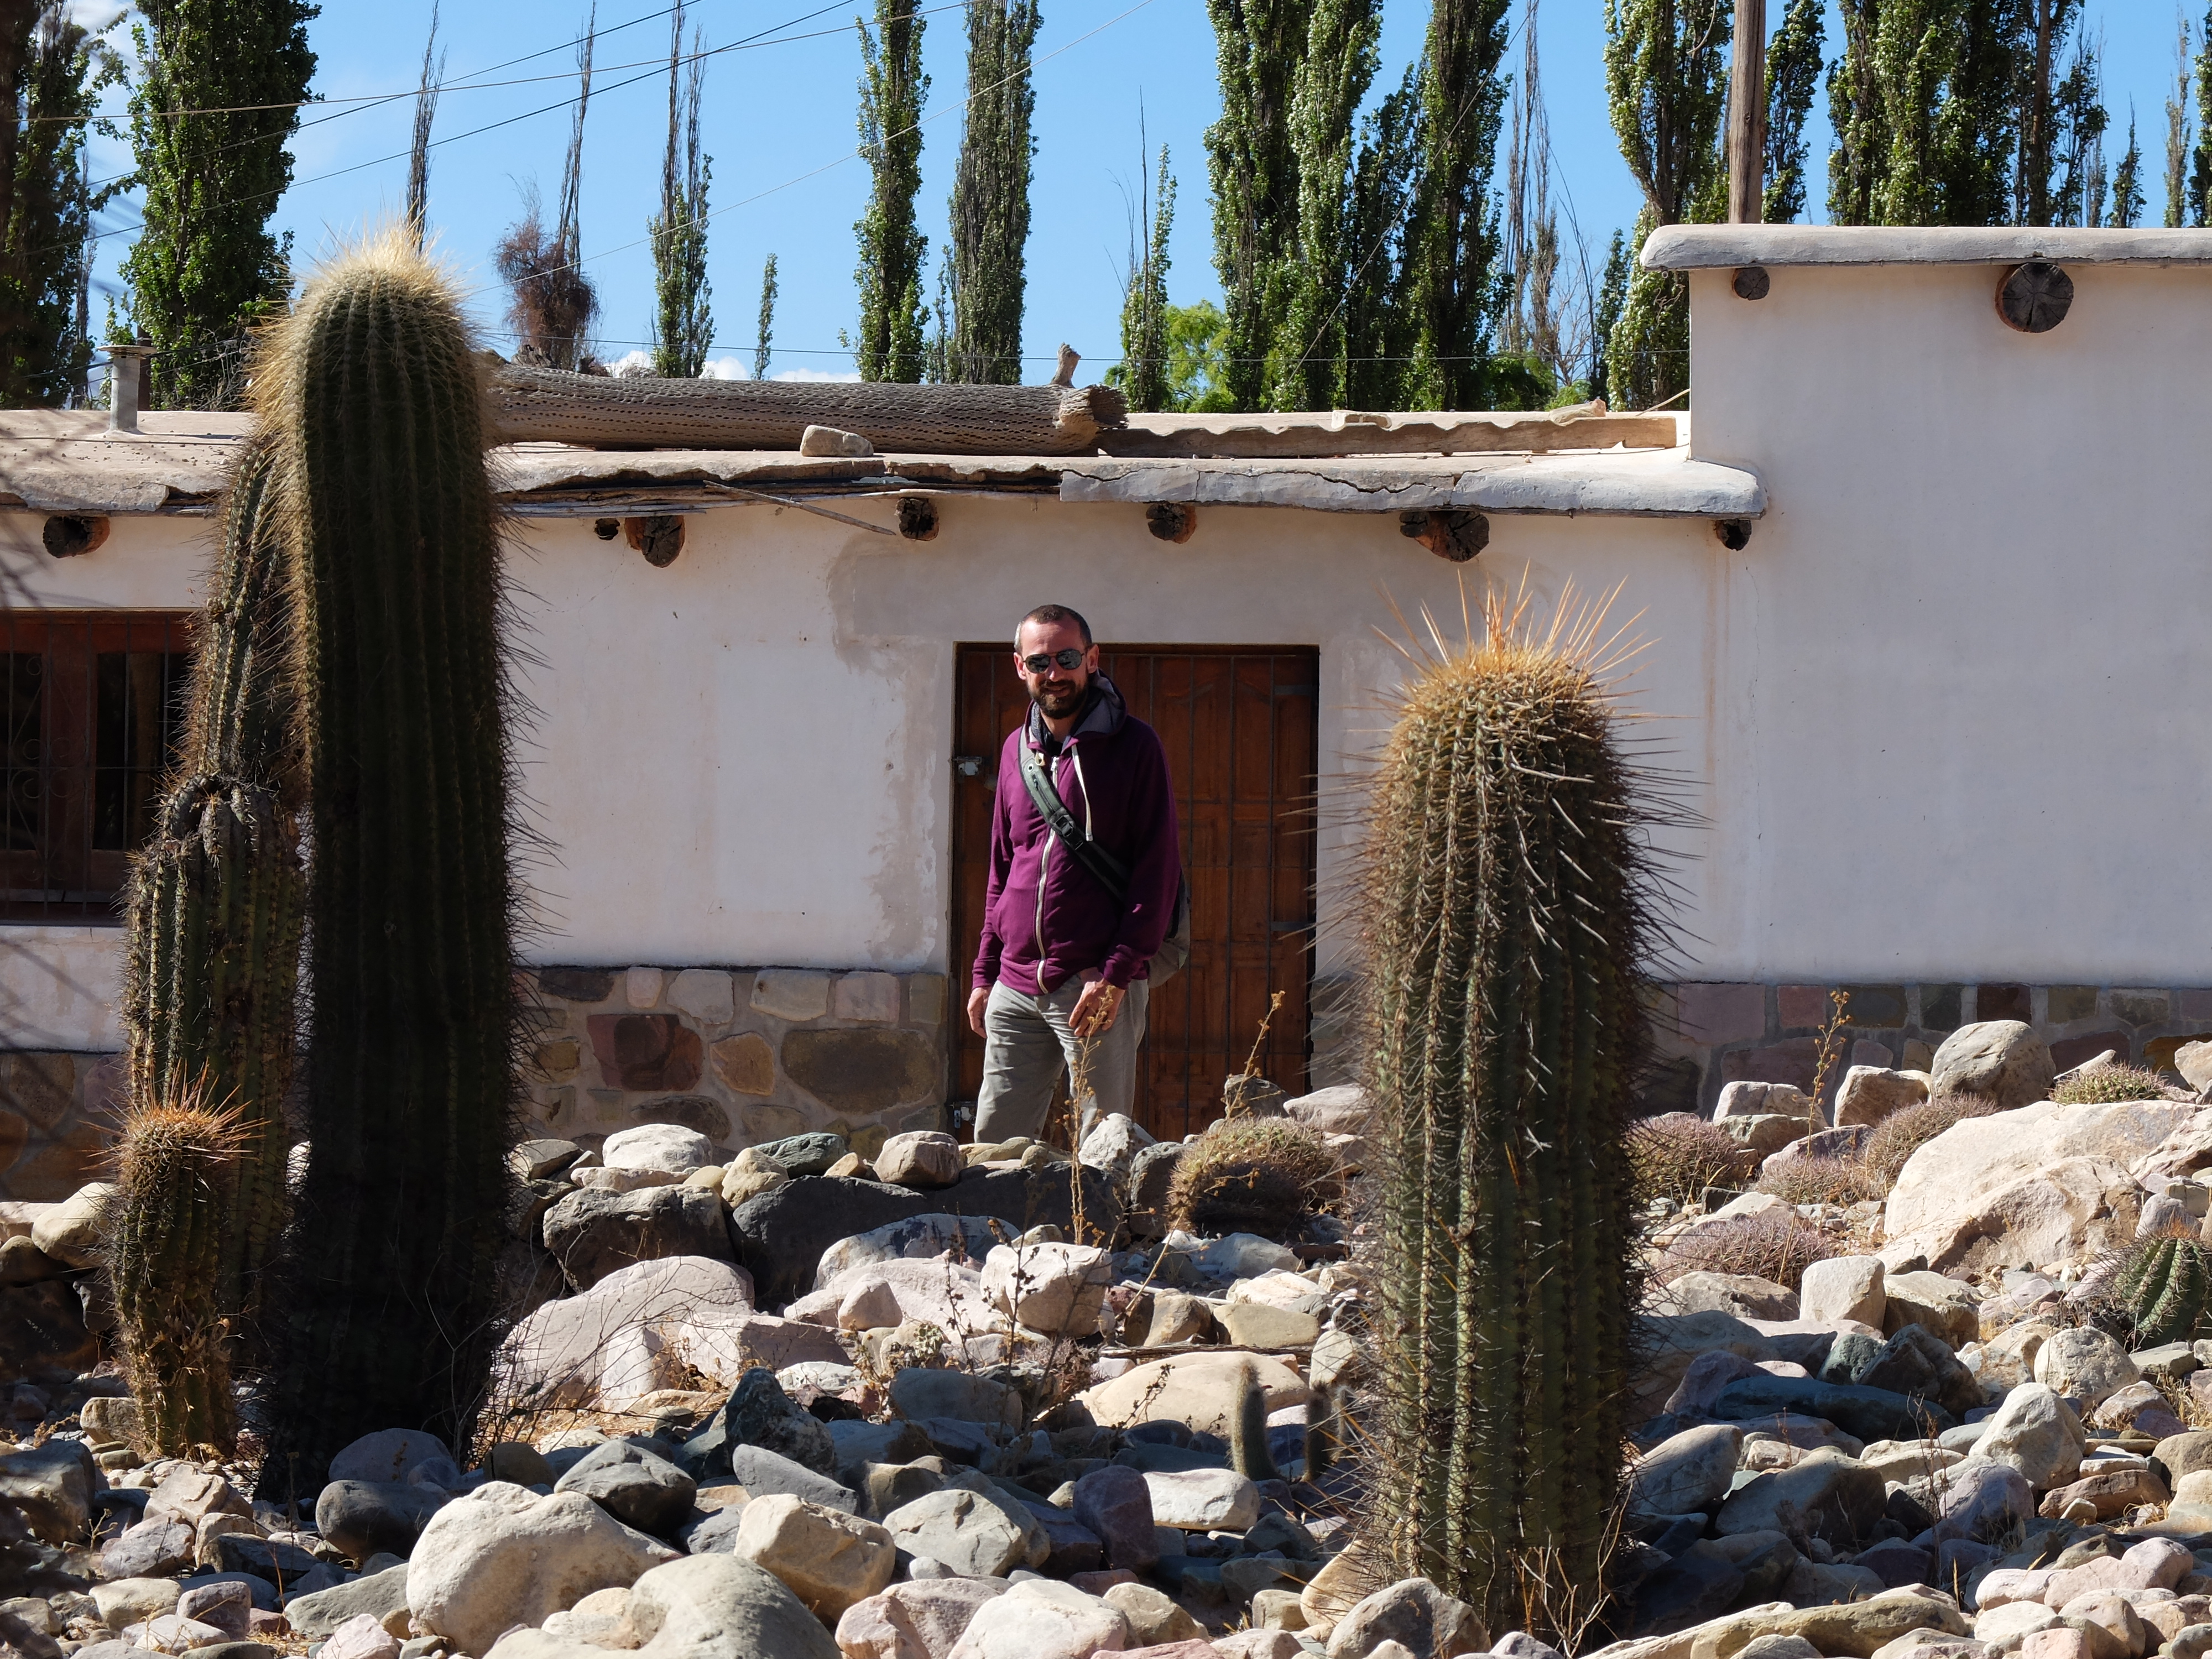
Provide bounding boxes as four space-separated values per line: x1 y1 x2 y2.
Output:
1365 604 1652 1635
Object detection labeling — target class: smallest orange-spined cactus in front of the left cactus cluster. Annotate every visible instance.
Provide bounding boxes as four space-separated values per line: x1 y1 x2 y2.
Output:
106 1097 241 1458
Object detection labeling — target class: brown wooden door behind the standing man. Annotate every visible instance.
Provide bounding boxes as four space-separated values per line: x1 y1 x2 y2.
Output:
951 644 1318 1139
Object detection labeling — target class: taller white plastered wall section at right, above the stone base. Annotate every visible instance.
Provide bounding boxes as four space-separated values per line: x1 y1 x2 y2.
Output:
1690 265 2212 984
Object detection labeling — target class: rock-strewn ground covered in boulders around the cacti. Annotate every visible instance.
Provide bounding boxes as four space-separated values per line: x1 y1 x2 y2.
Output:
0 1024 2212 1659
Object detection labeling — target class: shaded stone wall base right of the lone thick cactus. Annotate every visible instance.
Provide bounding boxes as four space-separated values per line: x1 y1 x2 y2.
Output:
1644 984 2212 1115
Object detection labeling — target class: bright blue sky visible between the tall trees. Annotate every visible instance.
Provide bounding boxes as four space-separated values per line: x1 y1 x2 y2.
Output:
78 0 2174 378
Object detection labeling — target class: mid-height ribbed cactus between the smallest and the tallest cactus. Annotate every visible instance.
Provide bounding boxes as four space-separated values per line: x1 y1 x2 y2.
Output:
124 776 303 1354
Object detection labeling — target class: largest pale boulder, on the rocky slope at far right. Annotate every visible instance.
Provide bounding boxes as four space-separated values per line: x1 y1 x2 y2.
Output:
1882 1099 2205 1279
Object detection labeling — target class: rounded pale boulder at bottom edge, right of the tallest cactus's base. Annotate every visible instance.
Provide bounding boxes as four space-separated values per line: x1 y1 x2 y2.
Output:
407 1480 677 1652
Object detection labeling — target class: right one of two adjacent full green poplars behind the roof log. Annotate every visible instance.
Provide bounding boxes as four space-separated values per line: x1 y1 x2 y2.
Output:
945 0 1037 385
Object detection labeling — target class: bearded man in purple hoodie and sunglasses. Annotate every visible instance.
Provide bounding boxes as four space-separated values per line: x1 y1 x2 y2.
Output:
969 604 1183 1141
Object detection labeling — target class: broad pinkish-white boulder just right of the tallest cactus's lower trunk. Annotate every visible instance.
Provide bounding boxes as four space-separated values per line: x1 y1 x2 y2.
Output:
493 1256 847 1411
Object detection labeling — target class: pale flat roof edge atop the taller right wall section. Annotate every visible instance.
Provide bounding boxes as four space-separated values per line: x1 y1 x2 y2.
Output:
1641 226 2212 270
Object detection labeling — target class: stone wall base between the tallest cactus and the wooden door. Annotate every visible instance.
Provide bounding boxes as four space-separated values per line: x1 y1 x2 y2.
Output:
524 967 947 1157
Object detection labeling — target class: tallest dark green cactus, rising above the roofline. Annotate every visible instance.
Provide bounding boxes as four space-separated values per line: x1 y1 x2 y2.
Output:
254 241 518 1491
